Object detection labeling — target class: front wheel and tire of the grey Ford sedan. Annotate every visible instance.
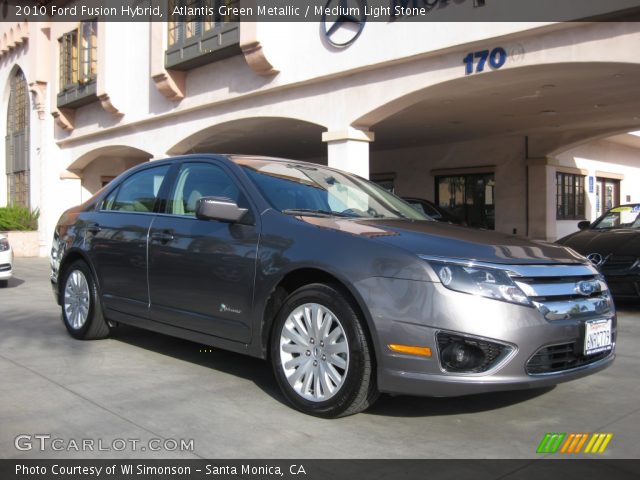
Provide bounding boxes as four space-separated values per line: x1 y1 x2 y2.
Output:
270 284 378 418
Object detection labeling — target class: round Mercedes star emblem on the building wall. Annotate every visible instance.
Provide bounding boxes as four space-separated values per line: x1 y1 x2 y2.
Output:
322 0 367 48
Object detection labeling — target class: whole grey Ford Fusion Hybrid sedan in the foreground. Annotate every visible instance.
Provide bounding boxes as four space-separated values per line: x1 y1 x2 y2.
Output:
51 154 616 417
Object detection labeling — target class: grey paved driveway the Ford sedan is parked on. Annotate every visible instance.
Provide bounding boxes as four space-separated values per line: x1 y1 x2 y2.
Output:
0 259 640 458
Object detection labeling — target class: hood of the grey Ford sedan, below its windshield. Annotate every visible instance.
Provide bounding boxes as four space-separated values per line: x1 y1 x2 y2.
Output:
300 217 584 264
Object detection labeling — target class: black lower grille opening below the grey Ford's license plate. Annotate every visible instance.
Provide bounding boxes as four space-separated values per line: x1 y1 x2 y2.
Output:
526 342 612 375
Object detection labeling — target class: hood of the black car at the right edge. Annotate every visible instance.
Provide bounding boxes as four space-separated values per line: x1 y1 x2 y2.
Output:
558 228 640 255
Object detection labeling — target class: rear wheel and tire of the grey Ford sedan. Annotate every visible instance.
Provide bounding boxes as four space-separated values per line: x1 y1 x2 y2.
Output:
61 260 110 340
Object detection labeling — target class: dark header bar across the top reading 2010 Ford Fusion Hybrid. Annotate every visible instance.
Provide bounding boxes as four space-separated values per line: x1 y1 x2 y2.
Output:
0 0 640 23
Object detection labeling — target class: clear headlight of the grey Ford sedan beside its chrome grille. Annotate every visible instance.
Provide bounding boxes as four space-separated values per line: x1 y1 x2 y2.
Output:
425 259 531 305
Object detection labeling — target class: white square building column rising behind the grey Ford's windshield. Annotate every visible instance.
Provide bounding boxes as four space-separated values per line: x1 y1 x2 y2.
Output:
322 127 375 178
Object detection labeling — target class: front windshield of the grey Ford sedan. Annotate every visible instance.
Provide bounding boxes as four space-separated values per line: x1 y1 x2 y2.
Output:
234 158 431 220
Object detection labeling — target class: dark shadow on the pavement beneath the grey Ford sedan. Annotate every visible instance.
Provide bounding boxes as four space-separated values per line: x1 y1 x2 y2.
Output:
107 325 554 417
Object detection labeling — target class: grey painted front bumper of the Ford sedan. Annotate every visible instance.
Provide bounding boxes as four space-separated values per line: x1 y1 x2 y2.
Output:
358 278 616 397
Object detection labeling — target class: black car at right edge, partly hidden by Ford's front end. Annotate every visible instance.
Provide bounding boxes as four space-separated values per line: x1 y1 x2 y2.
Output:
557 203 640 300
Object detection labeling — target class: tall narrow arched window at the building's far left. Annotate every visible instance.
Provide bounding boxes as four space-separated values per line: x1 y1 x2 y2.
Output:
5 69 29 208
